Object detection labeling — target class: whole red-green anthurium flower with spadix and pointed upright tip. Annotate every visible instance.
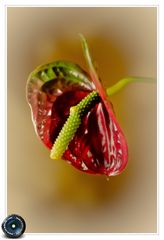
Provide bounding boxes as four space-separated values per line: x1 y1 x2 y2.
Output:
27 36 130 176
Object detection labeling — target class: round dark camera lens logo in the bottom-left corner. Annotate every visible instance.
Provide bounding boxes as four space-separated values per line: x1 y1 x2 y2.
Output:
2 214 26 238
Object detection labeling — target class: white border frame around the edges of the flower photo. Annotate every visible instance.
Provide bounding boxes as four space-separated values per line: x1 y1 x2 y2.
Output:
0 0 161 240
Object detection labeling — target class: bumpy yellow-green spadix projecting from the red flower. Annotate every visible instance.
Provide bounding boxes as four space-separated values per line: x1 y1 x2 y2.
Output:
50 91 100 160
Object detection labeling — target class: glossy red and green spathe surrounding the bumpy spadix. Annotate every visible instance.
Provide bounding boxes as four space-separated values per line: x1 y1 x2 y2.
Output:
27 61 128 176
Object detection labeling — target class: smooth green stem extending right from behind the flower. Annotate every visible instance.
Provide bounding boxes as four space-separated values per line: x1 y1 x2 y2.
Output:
106 77 155 96
